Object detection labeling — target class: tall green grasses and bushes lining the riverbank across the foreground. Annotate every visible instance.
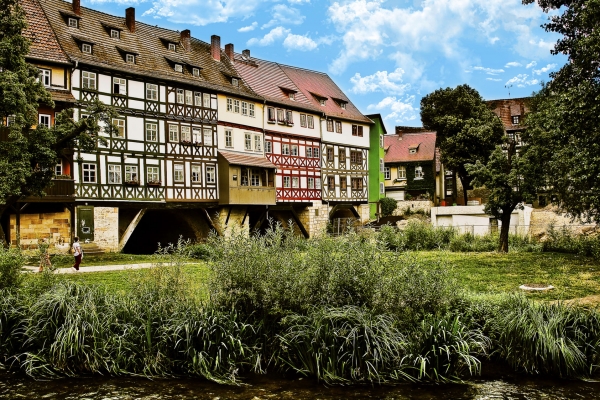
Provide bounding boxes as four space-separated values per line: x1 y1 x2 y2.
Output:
0 228 600 384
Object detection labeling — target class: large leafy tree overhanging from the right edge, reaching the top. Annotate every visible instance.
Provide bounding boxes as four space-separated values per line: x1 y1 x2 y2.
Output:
523 0 600 222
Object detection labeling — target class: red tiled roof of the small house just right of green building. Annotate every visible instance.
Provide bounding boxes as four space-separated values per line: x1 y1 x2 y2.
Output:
384 132 435 163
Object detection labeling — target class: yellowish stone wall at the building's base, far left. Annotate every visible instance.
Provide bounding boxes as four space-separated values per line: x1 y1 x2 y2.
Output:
10 210 71 249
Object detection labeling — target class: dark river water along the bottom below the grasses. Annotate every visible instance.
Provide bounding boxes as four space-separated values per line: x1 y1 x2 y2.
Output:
0 374 600 400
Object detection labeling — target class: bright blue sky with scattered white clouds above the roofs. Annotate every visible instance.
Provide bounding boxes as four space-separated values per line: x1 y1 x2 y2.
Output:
86 0 566 132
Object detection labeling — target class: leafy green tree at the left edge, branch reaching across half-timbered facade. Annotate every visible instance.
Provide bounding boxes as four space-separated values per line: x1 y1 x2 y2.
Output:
0 0 116 242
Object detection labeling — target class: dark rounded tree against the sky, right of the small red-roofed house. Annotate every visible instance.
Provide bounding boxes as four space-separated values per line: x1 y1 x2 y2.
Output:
421 85 504 202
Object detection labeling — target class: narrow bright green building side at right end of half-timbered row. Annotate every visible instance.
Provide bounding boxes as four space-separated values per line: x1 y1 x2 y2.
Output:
367 114 387 219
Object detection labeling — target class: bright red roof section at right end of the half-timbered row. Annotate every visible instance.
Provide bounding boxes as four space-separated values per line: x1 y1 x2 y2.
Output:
281 65 373 124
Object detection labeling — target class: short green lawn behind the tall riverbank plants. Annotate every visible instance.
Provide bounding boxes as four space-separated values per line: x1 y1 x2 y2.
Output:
56 251 600 300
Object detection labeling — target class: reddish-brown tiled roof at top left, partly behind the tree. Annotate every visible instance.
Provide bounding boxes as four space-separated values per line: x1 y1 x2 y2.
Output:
20 0 70 64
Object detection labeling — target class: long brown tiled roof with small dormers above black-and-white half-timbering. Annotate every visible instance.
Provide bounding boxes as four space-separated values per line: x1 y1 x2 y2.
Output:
34 0 261 99
